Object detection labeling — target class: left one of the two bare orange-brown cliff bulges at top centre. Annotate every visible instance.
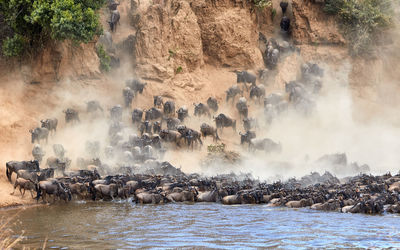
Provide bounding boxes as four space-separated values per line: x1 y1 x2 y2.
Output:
134 1 204 81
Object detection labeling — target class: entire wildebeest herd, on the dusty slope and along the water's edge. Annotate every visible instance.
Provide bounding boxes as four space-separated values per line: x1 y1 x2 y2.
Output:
6 56 400 214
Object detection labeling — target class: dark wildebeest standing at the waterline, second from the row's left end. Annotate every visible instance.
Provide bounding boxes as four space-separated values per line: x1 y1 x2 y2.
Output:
36 179 72 202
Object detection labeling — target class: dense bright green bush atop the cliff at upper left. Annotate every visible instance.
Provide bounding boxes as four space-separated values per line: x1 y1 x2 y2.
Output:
0 0 106 57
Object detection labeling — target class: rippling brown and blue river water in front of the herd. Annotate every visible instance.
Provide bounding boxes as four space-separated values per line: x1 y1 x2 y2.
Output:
0 201 400 249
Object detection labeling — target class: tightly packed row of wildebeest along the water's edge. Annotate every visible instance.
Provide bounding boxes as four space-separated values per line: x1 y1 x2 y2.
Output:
7 162 400 214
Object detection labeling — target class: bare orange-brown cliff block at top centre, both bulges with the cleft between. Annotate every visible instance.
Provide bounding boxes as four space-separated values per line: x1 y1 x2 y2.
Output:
134 0 263 81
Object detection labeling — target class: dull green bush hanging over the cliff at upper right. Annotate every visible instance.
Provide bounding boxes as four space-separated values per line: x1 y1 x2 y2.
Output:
324 0 393 55
